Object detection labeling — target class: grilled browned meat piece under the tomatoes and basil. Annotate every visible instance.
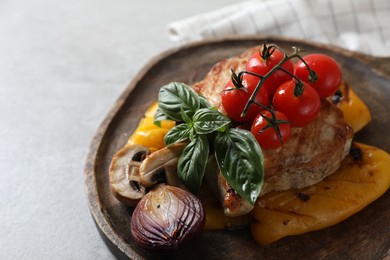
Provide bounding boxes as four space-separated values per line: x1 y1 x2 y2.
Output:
193 47 353 216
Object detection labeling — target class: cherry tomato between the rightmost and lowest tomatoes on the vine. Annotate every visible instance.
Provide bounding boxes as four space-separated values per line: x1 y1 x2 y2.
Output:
273 80 321 127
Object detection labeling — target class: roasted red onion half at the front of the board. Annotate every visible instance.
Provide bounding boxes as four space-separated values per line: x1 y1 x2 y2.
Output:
131 184 205 249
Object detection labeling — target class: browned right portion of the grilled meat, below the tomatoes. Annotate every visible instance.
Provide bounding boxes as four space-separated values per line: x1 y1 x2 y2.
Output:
261 100 353 195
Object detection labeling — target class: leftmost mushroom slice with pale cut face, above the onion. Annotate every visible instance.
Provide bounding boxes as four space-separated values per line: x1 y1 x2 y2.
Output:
109 144 150 206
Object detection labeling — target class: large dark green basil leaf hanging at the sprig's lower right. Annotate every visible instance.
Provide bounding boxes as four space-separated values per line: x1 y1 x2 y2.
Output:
214 128 264 205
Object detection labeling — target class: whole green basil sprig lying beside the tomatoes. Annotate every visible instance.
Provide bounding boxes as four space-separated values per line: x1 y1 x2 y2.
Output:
154 82 264 204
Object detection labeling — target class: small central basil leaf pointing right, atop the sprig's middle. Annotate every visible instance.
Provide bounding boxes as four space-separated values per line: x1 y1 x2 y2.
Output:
193 108 230 134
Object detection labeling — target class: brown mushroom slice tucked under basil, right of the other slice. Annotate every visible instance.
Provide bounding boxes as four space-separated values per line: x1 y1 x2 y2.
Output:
139 143 186 189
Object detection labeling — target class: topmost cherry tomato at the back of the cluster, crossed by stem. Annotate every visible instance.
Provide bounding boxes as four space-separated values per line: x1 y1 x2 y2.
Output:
246 46 294 97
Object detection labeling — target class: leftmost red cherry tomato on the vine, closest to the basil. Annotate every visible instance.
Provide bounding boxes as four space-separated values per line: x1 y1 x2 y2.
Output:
221 80 268 122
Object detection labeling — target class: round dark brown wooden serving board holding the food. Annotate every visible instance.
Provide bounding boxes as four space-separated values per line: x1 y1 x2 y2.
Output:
85 37 390 259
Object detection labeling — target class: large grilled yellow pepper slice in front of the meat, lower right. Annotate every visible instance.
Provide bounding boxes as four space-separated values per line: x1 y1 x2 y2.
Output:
251 143 390 244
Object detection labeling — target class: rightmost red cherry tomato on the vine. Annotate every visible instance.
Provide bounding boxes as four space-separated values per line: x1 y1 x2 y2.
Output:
294 54 342 98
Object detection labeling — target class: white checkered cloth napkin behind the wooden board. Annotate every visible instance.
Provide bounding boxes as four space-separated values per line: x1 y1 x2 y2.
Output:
168 0 390 57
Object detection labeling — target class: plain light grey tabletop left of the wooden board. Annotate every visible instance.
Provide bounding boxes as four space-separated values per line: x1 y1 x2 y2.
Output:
0 0 236 259
